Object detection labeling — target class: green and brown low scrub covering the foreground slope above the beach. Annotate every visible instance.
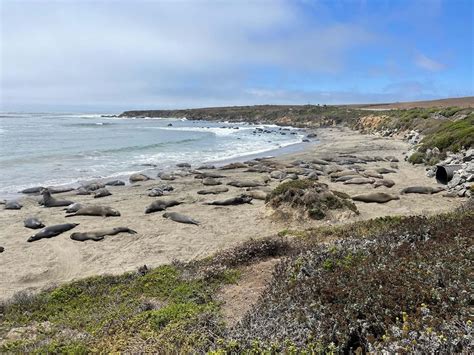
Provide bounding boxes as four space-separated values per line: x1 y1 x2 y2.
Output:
0 203 474 354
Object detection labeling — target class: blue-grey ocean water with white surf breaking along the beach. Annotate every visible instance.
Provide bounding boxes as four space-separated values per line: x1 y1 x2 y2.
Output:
0 113 303 198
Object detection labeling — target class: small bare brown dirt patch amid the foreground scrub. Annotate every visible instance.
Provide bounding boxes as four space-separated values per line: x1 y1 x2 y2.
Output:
218 259 280 327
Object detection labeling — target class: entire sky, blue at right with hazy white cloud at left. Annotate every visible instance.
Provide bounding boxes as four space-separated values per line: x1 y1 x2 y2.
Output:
0 0 474 112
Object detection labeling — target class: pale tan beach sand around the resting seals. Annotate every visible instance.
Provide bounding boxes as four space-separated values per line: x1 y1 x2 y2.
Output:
0 128 463 300
